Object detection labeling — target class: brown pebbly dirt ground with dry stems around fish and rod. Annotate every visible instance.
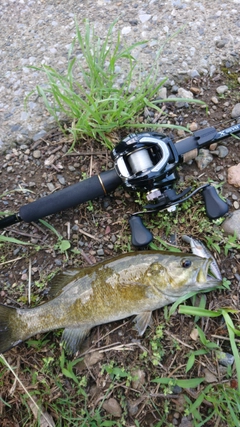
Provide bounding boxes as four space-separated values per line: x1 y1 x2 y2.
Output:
0 65 240 427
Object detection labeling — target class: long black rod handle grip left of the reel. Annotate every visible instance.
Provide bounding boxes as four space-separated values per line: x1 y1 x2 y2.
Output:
19 169 122 222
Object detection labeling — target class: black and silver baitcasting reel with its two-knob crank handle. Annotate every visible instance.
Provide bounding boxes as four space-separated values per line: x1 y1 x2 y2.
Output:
112 130 231 246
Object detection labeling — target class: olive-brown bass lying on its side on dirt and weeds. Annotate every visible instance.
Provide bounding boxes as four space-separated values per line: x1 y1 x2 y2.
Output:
0 250 221 354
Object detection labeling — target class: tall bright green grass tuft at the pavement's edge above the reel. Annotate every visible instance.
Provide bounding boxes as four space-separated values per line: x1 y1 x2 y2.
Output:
27 21 203 149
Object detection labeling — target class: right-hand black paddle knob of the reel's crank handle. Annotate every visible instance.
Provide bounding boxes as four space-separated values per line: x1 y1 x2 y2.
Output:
202 185 229 219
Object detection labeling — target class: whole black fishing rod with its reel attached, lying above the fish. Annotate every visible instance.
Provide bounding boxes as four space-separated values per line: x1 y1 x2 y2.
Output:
0 124 240 246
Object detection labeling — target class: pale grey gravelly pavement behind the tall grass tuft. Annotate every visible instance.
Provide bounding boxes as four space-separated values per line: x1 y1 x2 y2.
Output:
0 0 240 150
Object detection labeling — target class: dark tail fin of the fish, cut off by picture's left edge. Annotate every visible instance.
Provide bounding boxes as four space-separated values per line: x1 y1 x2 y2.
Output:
0 304 21 353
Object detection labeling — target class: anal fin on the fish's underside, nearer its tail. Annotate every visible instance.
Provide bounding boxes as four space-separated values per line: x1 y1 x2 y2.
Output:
62 325 91 354
